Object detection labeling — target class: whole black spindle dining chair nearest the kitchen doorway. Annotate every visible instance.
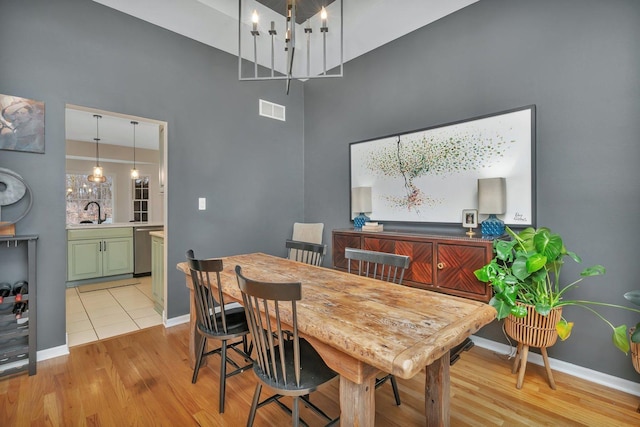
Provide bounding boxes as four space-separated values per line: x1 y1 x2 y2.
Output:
187 250 252 414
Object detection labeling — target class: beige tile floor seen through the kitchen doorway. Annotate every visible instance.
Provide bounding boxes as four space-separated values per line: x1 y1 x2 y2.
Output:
66 277 162 347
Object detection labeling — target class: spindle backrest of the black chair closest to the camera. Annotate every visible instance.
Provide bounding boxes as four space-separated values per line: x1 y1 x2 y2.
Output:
236 265 302 387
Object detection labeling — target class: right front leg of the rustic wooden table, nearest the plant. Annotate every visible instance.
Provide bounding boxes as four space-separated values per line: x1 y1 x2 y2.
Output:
424 351 451 427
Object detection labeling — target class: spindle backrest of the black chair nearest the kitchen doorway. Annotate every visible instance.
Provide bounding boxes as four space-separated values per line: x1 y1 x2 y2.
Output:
187 249 228 334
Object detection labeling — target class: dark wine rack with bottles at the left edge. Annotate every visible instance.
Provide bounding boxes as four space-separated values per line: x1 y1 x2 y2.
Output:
0 235 38 377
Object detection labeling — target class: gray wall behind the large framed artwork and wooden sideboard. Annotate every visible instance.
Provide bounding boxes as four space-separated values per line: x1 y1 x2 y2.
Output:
305 0 640 381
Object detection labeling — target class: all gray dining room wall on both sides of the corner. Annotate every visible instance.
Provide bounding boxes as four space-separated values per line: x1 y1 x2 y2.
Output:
0 0 640 380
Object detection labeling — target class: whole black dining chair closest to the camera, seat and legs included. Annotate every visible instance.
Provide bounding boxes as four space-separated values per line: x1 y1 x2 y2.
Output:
236 265 338 427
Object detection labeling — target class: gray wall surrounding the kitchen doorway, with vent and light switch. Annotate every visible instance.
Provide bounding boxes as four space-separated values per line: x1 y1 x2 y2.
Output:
0 0 304 349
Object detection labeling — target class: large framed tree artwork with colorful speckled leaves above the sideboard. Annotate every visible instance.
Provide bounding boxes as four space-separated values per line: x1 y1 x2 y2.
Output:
349 105 536 226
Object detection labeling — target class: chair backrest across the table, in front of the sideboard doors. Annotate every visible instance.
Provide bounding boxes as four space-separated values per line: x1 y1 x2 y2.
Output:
344 248 409 285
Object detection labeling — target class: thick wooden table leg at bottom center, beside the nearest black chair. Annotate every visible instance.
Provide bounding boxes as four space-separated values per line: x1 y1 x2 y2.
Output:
340 376 376 427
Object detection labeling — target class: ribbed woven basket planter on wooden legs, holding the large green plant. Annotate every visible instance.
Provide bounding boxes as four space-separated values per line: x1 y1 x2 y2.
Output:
504 303 562 348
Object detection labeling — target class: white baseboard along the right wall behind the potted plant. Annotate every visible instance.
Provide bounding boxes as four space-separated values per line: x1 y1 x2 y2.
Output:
471 335 640 396
